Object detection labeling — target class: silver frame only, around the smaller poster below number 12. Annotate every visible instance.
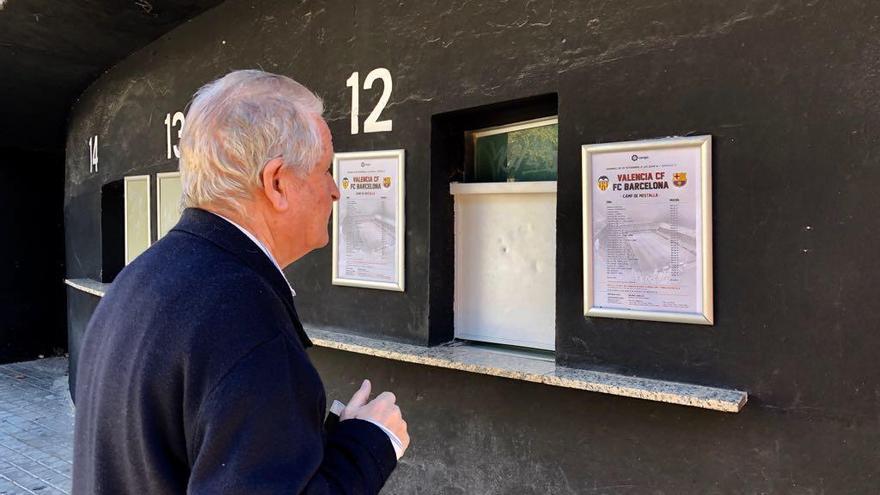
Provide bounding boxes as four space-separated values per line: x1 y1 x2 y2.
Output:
331 149 406 292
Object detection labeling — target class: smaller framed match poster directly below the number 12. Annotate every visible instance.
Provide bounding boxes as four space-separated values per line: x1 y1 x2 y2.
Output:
333 150 406 292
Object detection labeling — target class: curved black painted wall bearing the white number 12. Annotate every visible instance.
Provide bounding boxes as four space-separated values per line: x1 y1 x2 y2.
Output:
65 0 880 493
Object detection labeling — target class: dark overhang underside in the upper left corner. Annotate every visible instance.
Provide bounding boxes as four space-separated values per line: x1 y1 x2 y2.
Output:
0 0 222 152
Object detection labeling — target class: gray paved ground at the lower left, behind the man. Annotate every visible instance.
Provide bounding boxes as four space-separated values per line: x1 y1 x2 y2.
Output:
0 358 73 495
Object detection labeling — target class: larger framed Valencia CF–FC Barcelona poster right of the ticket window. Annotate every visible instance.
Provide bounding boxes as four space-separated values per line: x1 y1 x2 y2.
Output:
581 136 714 325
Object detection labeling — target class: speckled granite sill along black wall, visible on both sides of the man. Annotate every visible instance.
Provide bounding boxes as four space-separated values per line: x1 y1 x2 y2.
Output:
64 279 748 413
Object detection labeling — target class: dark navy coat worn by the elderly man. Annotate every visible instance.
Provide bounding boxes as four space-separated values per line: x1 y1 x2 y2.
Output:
73 209 396 495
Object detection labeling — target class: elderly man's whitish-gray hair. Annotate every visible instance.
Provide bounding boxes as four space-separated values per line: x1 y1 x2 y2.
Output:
180 70 324 208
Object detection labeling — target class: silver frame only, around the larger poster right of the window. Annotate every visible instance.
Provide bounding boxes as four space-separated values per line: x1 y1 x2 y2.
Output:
581 135 715 325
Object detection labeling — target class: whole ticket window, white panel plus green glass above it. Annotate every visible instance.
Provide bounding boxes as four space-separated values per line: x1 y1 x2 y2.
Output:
450 117 558 350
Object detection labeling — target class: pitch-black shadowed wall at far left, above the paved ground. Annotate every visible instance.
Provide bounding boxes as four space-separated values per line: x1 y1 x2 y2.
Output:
0 147 67 363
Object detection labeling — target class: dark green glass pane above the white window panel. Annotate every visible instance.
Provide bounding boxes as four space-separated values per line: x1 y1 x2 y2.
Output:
473 124 559 182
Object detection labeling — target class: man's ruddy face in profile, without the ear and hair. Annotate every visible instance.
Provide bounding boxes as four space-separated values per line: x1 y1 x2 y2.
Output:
288 119 339 250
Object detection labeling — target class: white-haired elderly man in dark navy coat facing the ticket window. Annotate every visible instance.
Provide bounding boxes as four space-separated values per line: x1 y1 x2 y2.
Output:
73 71 409 495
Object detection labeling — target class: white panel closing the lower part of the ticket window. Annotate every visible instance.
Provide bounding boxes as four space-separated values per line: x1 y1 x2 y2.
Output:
452 181 556 350
